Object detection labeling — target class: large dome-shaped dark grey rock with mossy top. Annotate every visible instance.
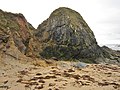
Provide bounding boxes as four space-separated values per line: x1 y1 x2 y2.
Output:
35 7 102 59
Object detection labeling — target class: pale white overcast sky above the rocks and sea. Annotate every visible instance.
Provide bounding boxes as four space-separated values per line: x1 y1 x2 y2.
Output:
0 0 120 44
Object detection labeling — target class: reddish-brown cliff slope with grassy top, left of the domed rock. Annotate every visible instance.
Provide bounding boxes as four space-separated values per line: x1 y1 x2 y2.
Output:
0 10 34 56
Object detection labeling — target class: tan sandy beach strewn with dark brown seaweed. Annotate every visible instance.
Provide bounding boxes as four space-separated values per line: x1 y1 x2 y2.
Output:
0 57 120 90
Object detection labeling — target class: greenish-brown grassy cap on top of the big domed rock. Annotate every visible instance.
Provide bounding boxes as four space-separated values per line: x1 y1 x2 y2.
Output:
50 7 88 30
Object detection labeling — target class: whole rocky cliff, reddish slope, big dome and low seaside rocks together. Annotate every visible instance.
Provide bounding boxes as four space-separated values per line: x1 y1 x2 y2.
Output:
0 7 120 64
